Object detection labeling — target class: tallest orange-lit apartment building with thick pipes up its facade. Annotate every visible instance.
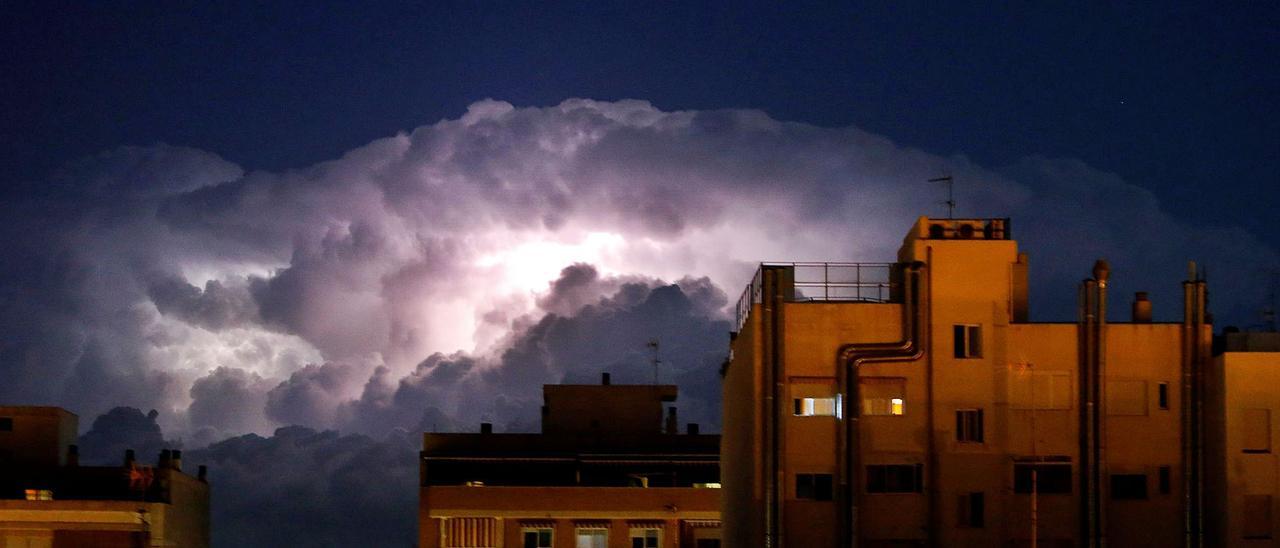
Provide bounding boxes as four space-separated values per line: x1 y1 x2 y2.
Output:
722 218 1212 547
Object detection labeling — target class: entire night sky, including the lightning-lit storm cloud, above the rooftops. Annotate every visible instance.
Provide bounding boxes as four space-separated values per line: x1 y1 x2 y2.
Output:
0 3 1280 547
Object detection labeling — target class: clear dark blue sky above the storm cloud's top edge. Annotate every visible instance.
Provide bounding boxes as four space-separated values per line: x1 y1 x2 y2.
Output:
0 1 1280 239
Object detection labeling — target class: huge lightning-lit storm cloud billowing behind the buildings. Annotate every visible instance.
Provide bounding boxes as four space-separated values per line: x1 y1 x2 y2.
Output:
0 100 1277 434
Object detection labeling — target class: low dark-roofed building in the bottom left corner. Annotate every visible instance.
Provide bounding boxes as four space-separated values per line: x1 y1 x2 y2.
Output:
0 406 209 548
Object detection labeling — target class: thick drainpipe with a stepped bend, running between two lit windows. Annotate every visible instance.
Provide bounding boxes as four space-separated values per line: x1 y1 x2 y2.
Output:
836 261 933 547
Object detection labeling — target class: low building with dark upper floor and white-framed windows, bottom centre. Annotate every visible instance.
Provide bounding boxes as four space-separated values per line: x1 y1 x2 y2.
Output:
419 374 721 548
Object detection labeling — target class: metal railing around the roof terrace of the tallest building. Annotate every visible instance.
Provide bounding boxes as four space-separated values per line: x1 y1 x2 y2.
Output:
733 262 897 333
